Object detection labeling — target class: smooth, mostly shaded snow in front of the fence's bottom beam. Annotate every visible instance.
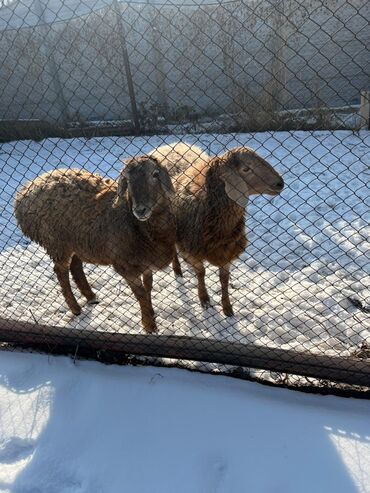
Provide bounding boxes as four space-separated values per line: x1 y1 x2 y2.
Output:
0 353 370 493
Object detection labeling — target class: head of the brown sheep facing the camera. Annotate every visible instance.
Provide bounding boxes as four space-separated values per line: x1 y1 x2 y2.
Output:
113 156 175 221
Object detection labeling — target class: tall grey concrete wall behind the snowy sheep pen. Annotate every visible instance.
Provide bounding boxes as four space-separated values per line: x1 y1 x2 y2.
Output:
0 0 370 121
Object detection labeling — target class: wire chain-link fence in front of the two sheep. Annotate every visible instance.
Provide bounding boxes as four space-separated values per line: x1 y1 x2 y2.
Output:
0 0 370 388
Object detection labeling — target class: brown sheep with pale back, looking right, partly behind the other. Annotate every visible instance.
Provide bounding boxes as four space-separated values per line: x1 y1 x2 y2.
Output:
149 143 284 317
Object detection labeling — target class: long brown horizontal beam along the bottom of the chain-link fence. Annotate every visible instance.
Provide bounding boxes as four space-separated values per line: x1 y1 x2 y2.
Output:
0 318 370 386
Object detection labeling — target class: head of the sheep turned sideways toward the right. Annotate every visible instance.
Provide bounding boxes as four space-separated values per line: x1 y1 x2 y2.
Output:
219 147 284 207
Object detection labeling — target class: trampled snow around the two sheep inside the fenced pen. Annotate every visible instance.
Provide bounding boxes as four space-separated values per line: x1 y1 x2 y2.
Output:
0 131 370 354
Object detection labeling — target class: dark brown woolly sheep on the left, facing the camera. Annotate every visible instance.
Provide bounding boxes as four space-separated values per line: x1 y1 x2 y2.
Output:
14 156 176 333
